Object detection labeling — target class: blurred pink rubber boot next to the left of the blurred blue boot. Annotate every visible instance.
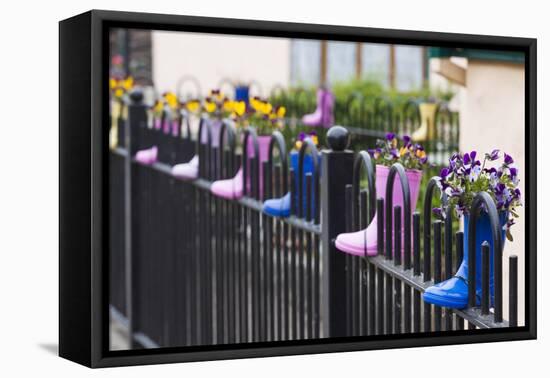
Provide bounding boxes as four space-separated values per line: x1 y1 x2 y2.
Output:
210 136 271 200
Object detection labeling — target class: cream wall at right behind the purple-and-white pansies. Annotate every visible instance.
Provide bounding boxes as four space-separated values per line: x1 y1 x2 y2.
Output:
460 60 525 322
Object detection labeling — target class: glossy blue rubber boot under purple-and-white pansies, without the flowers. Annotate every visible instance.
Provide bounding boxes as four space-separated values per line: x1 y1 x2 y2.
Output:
422 212 507 309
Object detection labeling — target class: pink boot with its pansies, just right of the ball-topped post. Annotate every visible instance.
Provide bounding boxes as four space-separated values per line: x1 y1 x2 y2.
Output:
335 133 427 256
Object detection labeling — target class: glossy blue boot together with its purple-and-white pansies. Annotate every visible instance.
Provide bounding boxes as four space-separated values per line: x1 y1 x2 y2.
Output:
423 150 521 309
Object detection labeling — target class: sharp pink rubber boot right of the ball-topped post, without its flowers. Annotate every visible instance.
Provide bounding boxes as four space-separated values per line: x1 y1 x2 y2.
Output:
335 165 422 256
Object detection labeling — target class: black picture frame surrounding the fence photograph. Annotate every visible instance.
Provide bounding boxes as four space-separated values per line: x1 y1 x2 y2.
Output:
59 10 537 367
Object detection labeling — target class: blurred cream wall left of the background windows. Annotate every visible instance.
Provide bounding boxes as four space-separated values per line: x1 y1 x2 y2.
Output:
149 31 290 96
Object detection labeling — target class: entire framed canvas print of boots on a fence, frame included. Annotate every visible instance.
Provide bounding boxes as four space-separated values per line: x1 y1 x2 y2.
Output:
59 10 536 367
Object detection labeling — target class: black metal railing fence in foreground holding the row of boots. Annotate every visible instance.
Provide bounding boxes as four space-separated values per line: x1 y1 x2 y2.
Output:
109 94 517 347
